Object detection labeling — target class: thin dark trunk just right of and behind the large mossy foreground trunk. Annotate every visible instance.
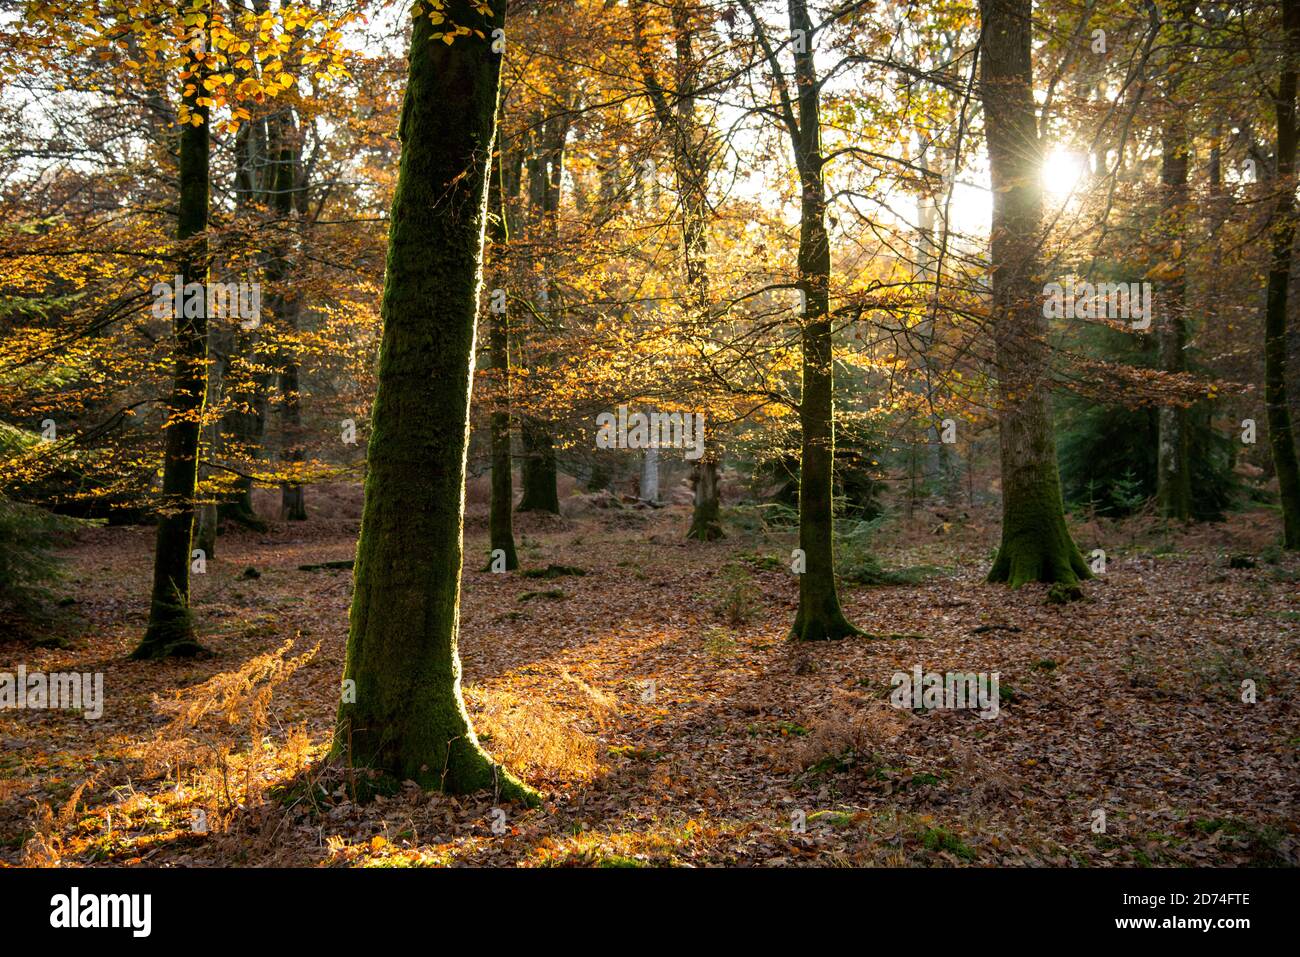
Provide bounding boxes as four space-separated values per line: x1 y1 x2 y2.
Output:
488 138 519 571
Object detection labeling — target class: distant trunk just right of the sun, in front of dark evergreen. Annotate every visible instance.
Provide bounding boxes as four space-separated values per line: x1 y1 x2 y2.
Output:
1156 118 1192 521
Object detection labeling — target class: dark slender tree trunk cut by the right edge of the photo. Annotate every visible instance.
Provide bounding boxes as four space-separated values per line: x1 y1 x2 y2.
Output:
1264 0 1300 549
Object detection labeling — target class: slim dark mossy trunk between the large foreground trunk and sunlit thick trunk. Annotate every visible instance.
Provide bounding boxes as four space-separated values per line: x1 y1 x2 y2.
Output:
789 0 859 641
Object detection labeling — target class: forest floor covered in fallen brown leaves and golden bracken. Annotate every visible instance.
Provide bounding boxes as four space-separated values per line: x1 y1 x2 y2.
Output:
0 488 1300 866
